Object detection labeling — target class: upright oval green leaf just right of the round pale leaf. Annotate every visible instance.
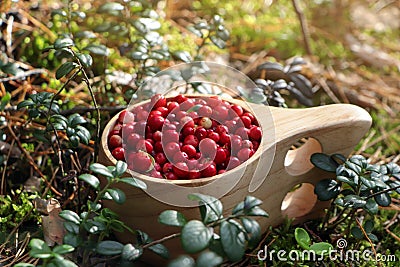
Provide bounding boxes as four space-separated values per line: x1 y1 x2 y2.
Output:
220 220 246 262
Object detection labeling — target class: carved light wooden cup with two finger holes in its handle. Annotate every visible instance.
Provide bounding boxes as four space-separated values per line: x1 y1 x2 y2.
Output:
99 97 371 264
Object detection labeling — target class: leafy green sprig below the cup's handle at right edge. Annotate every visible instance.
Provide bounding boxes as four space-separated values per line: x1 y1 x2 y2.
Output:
311 153 400 241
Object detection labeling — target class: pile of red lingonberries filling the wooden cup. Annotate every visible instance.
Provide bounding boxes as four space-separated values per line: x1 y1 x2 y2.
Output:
108 95 262 180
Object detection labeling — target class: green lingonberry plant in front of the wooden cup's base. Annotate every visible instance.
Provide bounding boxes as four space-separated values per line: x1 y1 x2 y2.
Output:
16 161 268 267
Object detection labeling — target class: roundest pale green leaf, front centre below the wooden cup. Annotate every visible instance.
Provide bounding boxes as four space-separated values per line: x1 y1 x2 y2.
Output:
181 220 212 253
